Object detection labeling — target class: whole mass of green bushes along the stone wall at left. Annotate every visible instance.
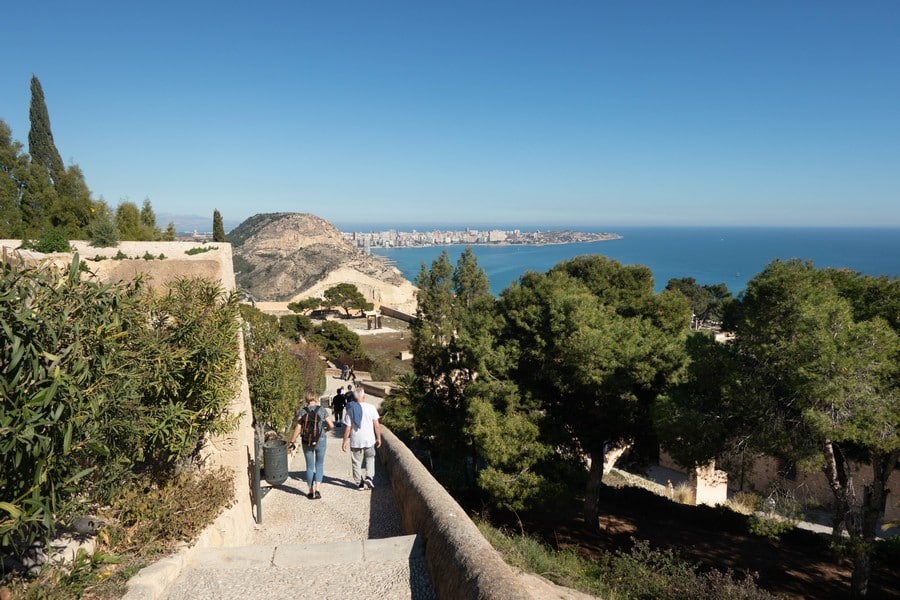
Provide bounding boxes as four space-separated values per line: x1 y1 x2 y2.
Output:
0 257 238 548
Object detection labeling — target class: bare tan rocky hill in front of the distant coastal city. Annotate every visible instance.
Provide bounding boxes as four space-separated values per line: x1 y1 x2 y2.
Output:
228 213 416 312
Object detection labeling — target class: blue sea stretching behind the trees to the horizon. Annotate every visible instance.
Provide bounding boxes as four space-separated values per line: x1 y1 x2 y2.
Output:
372 226 900 295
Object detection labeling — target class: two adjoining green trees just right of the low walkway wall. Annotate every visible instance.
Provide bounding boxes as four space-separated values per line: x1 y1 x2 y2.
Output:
385 249 690 522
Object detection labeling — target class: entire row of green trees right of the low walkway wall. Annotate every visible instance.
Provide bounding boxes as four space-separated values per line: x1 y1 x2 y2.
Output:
383 246 900 595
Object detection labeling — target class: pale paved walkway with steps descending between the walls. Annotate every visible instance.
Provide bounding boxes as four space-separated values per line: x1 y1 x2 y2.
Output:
164 377 434 600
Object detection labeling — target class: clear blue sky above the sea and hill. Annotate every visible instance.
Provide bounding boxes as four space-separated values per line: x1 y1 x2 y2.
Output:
0 0 900 227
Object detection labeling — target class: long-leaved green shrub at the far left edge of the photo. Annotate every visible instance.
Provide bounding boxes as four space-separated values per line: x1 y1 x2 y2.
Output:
0 255 138 549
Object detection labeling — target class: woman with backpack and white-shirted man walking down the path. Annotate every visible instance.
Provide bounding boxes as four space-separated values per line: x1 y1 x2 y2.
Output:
289 385 381 500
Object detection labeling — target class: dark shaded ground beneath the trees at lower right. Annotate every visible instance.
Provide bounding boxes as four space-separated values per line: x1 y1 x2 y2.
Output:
510 487 900 599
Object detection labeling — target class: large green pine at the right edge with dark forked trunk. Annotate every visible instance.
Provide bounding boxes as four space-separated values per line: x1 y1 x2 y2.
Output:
725 260 900 596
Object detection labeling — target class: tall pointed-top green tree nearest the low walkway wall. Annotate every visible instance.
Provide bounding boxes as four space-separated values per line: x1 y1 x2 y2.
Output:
400 248 552 510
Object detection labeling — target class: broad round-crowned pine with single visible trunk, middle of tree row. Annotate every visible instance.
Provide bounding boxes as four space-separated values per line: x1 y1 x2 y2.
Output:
500 256 690 526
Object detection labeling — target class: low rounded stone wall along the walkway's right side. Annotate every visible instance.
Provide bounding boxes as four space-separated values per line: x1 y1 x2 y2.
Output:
378 425 533 600
